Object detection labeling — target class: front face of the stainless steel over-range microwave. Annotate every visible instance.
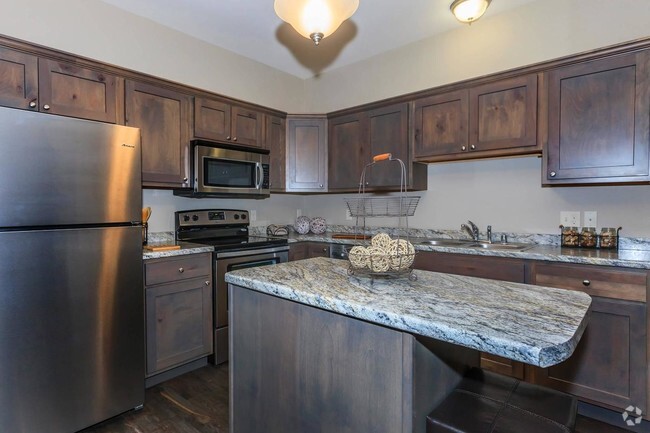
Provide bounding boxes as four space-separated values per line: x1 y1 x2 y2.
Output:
194 145 269 195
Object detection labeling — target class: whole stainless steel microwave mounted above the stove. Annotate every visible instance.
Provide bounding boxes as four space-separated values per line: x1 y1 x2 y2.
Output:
174 140 270 199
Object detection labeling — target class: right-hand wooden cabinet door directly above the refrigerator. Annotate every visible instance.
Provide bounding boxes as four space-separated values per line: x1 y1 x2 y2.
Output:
38 59 117 123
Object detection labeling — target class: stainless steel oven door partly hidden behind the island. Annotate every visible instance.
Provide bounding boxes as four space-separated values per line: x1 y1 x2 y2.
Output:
214 245 289 364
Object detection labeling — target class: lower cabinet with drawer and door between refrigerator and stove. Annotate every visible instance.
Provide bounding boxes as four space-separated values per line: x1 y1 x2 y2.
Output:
144 253 213 377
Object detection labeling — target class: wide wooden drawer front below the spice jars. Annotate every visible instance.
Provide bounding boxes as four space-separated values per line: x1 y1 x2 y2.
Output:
534 263 647 302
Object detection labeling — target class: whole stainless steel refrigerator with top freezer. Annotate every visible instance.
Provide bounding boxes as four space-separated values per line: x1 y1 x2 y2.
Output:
0 108 144 433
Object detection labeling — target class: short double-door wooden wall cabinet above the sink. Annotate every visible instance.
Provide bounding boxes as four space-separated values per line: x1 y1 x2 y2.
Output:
413 74 541 162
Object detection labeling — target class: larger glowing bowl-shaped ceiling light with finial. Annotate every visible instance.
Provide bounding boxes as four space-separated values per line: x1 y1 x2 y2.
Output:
273 0 359 45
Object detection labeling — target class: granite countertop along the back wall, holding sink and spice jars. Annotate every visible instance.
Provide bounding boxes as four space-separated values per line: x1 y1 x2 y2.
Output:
289 233 650 269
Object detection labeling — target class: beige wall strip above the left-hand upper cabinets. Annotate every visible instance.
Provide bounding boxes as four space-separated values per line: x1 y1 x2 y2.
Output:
0 0 304 112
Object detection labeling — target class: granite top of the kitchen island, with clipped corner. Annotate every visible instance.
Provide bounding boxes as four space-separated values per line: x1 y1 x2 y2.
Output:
226 258 591 367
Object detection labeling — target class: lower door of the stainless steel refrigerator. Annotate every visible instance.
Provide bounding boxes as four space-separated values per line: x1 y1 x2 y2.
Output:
0 227 145 433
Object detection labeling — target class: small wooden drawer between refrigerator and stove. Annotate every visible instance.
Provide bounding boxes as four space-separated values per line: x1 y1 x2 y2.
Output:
144 254 212 286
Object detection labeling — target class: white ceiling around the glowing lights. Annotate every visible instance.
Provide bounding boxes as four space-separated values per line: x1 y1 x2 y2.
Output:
102 0 543 78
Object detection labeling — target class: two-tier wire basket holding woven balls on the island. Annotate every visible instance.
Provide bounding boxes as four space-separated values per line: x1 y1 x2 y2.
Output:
345 153 420 280
